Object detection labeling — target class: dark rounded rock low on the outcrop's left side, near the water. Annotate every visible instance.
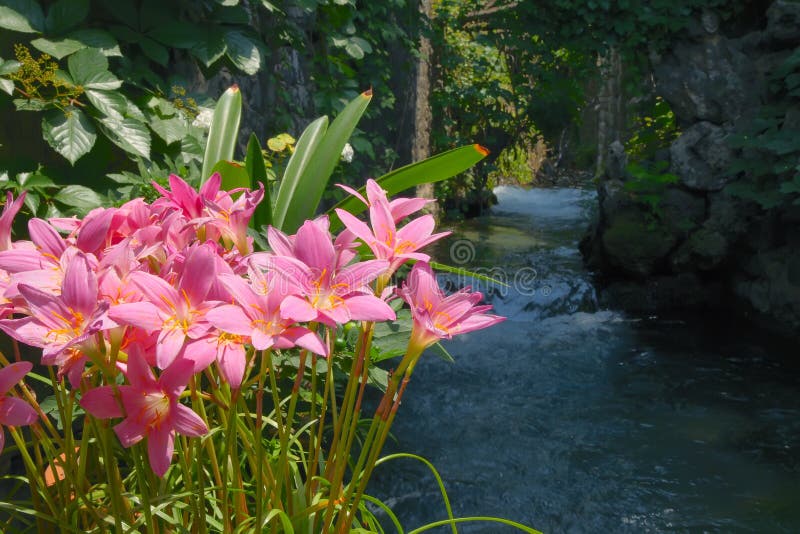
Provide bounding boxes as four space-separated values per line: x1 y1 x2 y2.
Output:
601 208 677 277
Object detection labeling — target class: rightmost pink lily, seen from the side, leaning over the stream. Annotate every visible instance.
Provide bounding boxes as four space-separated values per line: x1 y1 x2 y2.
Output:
397 262 506 349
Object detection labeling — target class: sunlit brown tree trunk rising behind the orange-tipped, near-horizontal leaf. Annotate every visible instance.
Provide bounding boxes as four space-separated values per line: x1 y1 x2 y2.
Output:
411 0 438 215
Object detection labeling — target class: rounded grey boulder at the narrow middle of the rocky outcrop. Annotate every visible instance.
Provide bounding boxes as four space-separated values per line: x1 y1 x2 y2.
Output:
670 121 733 191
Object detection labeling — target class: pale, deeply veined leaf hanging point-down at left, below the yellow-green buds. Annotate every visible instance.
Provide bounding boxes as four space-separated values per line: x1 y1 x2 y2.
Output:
42 106 97 165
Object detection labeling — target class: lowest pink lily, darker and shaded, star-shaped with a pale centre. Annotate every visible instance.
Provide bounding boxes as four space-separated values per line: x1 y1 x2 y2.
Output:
81 357 208 477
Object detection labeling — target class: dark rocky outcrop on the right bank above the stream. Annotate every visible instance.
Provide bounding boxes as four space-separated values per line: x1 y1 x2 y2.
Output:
581 0 800 336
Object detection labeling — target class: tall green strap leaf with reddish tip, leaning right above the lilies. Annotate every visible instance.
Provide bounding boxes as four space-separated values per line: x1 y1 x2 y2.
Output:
280 91 372 233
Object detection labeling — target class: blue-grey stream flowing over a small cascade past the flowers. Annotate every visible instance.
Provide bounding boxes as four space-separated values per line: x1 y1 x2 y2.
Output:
371 187 800 533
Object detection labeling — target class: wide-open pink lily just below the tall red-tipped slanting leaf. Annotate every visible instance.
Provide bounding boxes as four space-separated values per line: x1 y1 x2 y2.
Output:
269 221 395 325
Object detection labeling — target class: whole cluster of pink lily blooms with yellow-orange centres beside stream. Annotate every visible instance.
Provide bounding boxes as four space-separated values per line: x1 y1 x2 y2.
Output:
0 175 502 476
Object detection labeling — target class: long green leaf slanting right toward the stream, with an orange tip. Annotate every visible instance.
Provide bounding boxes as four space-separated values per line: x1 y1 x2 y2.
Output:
328 145 489 231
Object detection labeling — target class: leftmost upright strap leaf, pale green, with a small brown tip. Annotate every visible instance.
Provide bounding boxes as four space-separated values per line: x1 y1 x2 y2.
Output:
200 85 242 183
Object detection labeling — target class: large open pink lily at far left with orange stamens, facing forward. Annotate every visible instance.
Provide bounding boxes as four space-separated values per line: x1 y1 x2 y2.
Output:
0 253 117 386
